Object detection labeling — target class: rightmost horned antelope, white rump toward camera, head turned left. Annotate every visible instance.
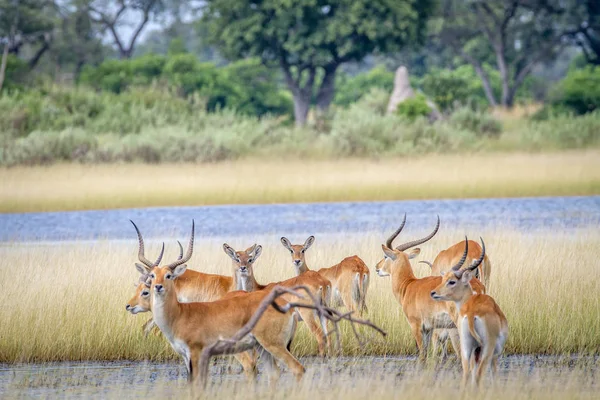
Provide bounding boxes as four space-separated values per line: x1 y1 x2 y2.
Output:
431 239 508 386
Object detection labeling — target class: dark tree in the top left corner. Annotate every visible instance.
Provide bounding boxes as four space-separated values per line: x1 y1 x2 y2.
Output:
0 0 54 89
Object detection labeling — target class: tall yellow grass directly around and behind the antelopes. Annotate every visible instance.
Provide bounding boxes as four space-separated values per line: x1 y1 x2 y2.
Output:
0 229 600 363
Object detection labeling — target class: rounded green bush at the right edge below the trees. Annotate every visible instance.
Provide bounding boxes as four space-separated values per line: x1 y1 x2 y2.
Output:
550 66 600 115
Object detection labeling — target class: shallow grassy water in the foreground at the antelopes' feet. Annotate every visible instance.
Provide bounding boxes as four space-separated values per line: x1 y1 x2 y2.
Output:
0 356 599 398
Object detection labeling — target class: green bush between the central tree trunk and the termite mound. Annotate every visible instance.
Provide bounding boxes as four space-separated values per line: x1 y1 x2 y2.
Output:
333 66 394 106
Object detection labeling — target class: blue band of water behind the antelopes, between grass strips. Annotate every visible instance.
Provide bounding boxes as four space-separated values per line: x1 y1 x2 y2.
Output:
0 196 600 241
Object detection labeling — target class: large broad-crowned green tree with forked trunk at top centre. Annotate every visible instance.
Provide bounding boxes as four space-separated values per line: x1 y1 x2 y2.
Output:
204 0 432 126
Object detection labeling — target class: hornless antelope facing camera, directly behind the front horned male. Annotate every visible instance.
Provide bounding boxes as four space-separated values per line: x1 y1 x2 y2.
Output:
223 243 331 356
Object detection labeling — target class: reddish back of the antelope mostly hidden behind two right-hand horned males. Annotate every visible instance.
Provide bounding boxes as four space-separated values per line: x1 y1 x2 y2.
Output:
419 240 492 288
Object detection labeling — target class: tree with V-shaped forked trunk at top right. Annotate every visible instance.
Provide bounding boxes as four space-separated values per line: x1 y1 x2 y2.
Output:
434 0 566 107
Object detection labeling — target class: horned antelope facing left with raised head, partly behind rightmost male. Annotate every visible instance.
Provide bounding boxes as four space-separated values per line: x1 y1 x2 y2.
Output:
376 215 486 361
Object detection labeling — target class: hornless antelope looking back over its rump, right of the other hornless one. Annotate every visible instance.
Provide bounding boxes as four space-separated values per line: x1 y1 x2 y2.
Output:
281 236 370 315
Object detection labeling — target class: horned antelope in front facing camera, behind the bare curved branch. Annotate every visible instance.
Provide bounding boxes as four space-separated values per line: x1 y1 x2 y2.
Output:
150 225 304 381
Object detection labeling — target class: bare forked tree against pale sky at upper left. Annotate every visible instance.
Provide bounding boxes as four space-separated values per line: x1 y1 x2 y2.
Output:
88 0 163 59
